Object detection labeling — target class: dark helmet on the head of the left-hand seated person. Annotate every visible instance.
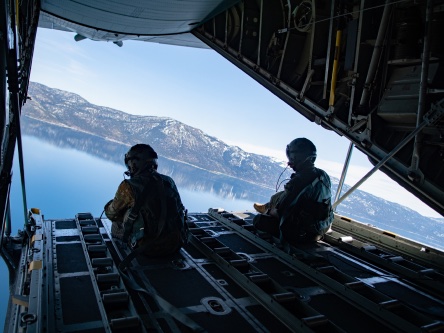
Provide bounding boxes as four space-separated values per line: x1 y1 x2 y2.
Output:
125 143 157 177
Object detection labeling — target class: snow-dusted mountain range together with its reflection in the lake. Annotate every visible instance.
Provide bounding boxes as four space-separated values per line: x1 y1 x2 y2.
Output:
21 82 444 248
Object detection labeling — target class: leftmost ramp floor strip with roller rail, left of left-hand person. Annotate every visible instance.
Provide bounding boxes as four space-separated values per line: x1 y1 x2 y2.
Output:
9 213 145 332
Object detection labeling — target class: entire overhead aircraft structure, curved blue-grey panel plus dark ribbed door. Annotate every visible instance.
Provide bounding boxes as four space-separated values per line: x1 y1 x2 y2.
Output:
35 0 444 213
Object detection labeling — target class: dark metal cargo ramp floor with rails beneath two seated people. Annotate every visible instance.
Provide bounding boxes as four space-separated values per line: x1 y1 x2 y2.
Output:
5 209 444 332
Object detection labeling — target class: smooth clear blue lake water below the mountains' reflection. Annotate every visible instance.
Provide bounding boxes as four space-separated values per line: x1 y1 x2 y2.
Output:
0 136 253 325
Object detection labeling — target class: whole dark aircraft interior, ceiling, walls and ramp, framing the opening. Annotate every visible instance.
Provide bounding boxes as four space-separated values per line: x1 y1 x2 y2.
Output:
0 0 444 333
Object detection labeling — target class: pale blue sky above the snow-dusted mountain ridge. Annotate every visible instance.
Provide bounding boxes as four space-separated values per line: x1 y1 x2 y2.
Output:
25 28 442 217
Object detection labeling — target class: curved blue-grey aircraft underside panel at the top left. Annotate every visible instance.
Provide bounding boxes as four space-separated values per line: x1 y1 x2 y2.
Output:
39 0 238 48
